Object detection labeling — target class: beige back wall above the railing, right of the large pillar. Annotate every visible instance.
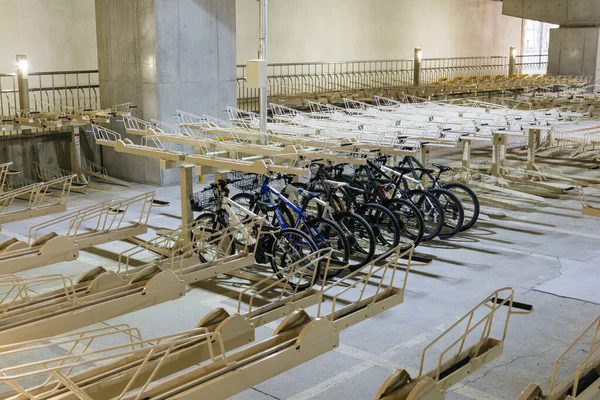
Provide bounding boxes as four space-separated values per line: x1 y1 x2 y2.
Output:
236 0 521 64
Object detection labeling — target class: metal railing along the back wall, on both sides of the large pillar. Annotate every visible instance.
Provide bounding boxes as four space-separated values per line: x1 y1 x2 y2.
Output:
0 54 548 116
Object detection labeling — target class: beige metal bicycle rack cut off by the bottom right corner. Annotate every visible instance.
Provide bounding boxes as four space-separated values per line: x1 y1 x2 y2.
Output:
518 317 600 400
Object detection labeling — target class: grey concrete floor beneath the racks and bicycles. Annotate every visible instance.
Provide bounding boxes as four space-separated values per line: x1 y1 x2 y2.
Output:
0 148 600 400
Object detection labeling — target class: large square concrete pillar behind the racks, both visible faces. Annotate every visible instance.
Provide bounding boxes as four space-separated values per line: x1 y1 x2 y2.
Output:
96 0 236 185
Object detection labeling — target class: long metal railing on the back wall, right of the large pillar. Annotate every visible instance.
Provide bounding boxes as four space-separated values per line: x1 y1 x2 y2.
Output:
237 54 548 111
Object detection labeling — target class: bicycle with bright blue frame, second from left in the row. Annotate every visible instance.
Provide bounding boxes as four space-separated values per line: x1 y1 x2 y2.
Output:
231 174 350 277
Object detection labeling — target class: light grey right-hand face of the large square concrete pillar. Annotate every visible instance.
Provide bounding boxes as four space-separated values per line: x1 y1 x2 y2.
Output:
156 0 237 122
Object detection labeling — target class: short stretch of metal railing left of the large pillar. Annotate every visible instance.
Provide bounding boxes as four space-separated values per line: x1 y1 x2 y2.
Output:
0 70 100 116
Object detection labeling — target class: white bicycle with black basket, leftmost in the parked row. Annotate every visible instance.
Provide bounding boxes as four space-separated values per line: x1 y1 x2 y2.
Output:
190 179 320 290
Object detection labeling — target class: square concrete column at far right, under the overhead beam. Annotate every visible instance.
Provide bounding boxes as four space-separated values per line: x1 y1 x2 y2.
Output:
548 27 600 84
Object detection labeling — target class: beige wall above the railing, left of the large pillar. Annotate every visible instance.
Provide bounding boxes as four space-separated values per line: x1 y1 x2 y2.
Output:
0 0 98 73
